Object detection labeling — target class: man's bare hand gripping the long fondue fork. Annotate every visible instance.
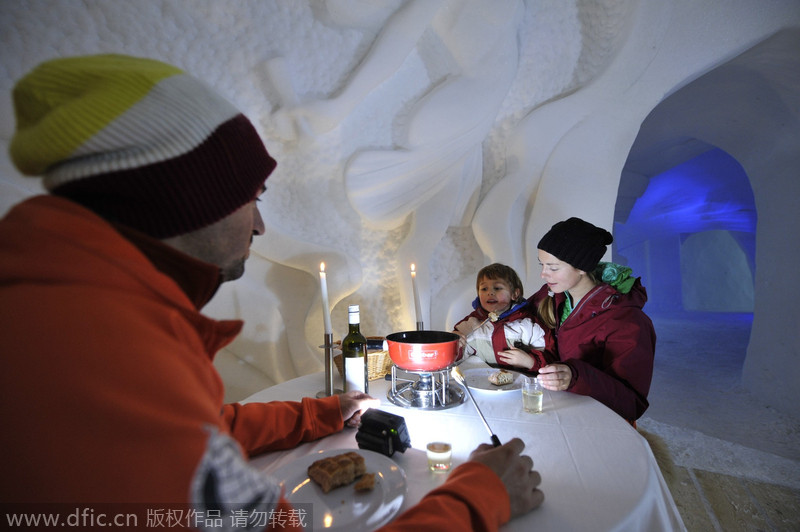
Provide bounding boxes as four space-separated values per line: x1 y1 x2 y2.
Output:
469 438 544 518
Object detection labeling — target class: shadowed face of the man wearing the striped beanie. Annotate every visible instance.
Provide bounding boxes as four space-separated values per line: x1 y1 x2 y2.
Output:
164 188 266 282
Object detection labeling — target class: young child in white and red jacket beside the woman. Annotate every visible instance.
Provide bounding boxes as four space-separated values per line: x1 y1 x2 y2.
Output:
454 263 554 371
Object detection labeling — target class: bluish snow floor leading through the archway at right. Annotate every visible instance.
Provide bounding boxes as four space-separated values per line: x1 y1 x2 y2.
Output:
638 313 800 489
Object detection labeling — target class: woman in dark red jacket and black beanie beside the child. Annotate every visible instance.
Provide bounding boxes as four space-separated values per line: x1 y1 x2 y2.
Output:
531 218 656 423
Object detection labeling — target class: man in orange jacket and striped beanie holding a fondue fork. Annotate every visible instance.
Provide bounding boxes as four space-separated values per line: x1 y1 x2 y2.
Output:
0 55 543 530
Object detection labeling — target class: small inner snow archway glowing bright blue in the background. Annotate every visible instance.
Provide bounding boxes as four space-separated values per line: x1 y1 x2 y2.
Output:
614 145 757 312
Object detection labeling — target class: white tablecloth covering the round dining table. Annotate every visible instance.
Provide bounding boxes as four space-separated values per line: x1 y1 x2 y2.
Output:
243 373 685 532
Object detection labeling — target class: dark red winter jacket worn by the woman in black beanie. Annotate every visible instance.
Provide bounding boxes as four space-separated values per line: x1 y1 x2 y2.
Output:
530 279 656 422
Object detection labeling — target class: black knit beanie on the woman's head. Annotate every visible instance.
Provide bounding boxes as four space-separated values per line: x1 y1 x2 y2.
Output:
537 217 614 272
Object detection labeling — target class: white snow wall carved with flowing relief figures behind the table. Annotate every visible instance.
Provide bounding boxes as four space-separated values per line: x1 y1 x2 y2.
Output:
0 0 800 408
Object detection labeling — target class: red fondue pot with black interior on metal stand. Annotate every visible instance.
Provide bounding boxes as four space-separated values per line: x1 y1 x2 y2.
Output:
386 331 460 371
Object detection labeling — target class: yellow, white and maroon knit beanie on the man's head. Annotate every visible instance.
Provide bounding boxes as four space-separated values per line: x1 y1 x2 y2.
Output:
10 55 276 239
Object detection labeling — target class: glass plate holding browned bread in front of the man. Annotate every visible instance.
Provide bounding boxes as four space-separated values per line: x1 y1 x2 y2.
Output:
272 449 406 532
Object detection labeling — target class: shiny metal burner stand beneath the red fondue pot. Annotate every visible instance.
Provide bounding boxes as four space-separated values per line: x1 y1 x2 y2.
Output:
386 364 464 410
